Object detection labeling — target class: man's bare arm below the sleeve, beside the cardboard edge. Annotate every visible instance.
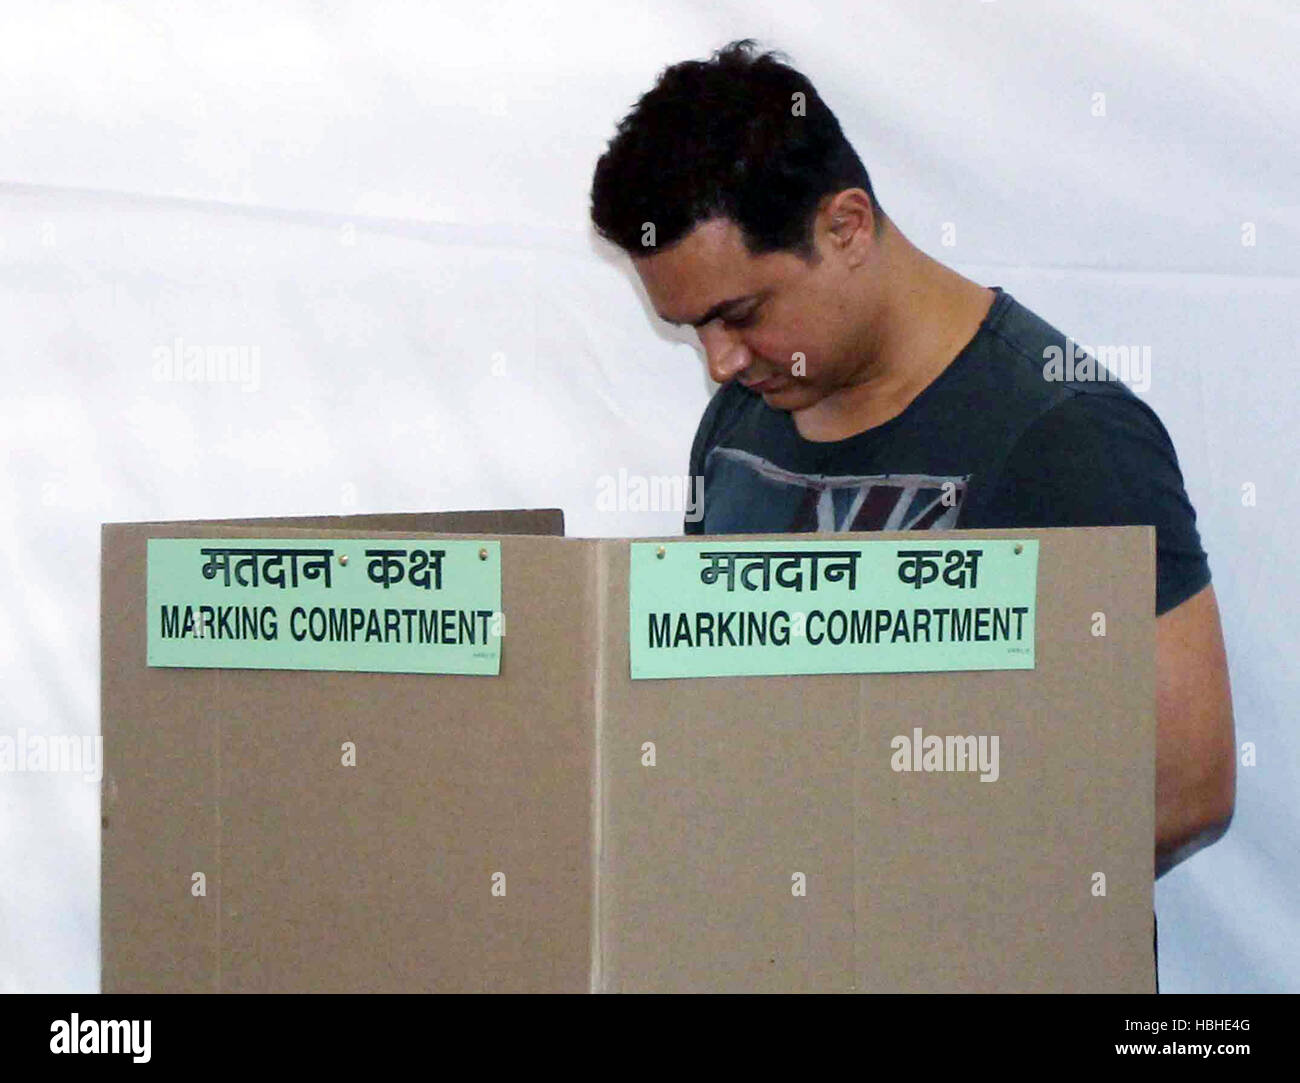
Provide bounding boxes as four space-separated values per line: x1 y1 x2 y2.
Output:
1156 585 1236 876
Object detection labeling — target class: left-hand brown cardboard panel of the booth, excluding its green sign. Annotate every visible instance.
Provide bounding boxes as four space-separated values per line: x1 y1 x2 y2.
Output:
101 524 595 992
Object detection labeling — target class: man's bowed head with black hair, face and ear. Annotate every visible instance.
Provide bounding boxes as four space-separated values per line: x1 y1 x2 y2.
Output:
592 40 885 410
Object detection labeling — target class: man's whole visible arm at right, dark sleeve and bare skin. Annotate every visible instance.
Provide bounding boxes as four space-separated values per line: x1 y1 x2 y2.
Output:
963 395 1236 876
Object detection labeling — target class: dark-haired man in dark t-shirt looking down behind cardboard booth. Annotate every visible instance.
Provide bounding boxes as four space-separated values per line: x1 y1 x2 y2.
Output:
592 40 1236 972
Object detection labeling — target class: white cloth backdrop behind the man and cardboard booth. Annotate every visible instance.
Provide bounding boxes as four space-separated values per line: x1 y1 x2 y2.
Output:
0 0 1300 992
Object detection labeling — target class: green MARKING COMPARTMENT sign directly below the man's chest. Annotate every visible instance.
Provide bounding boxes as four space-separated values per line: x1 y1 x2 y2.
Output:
629 534 1039 680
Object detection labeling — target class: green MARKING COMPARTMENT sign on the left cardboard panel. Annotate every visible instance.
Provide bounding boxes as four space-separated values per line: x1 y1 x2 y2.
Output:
147 538 504 676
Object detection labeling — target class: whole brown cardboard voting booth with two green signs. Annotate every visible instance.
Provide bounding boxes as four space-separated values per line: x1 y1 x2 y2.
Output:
101 512 1156 992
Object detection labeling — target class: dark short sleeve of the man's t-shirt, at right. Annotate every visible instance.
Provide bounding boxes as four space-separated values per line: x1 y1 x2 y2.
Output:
963 393 1210 616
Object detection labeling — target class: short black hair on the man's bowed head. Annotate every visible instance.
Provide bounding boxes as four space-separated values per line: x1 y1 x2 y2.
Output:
592 38 884 261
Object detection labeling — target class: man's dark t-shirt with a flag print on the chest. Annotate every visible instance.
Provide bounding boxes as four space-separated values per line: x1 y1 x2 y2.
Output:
685 286 1210 615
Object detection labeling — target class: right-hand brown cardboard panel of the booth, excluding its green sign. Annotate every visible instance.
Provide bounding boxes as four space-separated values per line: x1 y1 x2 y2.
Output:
598 527 1154 992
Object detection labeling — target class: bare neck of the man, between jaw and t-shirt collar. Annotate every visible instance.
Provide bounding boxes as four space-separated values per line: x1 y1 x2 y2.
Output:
793 230 995 441
